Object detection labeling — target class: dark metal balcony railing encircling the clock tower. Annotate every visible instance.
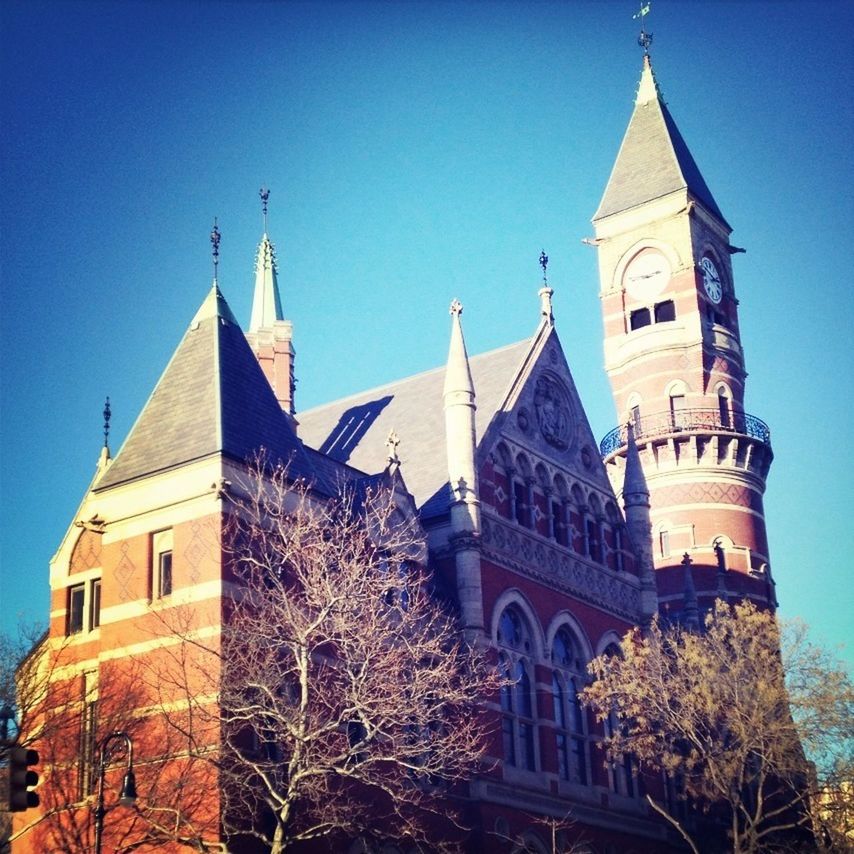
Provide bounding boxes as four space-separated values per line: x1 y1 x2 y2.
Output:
599 409 771 457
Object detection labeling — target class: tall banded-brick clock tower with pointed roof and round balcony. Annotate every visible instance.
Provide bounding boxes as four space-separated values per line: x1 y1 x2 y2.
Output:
593 54 774 611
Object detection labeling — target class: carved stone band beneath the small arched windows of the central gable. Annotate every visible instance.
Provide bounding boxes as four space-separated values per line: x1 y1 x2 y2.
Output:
481 514 640 622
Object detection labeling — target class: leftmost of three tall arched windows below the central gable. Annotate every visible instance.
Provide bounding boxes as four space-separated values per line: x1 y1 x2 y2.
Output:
497 605 537 771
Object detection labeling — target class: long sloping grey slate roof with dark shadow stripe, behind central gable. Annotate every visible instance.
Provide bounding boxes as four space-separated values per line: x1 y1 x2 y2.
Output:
297 340 531 507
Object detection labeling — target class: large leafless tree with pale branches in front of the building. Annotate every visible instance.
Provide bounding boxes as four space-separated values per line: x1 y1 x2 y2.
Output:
159 464 500 852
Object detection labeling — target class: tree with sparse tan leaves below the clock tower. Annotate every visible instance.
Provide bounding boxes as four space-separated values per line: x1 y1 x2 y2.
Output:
584 601 854 854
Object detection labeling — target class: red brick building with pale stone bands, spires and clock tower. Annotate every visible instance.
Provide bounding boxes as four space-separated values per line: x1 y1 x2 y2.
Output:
14 51 774 854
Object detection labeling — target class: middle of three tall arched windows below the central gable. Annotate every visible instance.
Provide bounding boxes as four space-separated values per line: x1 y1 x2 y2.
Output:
552 627 588 784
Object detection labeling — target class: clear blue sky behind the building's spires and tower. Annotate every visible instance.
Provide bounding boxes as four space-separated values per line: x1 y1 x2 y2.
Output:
0 0 854 660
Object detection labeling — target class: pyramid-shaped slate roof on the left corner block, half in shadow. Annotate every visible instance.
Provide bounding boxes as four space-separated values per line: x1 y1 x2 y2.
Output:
95 283 318 491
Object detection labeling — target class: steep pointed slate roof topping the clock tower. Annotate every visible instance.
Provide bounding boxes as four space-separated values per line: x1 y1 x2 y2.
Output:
593 56 729 227
